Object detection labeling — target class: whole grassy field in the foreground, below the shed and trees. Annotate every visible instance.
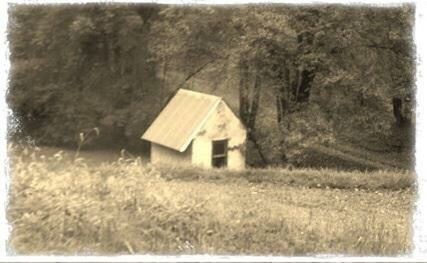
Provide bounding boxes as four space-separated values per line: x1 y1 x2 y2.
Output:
8 147 415 255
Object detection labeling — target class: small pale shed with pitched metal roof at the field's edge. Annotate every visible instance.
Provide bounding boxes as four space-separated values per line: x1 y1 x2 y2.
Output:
142 89 246 170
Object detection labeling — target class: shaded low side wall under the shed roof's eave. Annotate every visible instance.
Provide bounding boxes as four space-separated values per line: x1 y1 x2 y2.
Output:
150 143 192 166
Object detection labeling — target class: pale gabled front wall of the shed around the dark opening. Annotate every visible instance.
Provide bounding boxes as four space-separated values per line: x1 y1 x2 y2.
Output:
192 101 246 170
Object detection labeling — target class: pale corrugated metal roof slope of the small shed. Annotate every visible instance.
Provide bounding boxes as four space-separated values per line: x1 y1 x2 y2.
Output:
142 89 221 152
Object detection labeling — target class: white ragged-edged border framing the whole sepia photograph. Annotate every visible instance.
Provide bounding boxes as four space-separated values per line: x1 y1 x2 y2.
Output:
0 0 427 262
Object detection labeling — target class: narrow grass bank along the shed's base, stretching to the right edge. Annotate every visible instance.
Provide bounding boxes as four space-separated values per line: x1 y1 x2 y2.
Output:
159 166 415 191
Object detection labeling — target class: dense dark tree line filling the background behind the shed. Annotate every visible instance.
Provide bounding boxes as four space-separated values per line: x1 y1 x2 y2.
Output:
8 5 415 163
